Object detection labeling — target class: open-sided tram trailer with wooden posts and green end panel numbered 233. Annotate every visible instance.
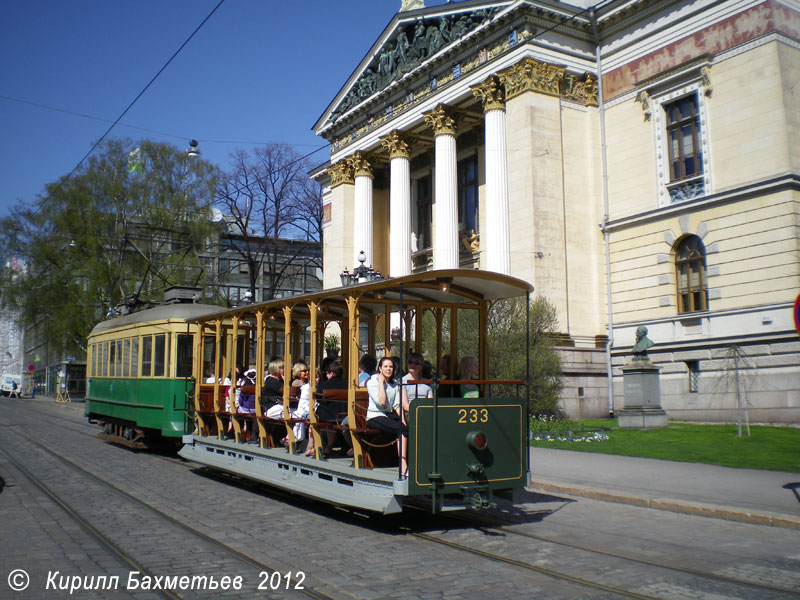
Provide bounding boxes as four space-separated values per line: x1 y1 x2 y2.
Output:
176 269 532 514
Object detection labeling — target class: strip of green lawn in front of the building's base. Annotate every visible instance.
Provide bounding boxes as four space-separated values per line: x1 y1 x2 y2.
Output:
531 420 800 473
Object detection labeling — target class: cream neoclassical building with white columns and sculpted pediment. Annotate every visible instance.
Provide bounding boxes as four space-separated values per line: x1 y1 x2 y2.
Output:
312 0 800 422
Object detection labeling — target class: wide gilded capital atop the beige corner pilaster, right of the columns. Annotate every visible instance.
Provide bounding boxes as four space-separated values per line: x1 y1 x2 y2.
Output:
499 58 597 106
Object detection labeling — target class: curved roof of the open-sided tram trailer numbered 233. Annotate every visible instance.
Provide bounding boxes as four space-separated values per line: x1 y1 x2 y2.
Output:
188 269 533 322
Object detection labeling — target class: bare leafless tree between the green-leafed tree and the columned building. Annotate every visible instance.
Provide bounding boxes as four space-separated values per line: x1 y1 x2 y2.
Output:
216 144 322 300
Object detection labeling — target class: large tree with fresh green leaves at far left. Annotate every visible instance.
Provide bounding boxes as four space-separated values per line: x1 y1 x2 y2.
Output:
0 140 215 352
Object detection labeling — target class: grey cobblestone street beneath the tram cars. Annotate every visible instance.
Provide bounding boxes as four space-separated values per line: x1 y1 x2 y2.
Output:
0 398 800 599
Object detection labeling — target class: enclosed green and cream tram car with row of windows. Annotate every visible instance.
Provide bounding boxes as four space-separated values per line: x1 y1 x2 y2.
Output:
85 302 220 449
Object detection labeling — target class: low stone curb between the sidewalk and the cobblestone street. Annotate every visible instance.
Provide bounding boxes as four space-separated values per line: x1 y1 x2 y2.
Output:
528 481 800 530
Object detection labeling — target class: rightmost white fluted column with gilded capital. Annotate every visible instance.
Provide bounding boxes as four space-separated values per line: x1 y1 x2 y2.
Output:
472 75 510 275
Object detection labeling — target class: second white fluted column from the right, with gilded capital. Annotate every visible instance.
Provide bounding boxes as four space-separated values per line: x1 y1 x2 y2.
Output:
423 104 459 269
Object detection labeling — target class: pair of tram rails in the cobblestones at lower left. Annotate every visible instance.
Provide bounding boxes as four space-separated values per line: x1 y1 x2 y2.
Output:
0 427 334 600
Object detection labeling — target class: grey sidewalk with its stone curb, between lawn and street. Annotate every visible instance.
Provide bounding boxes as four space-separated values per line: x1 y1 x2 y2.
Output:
530 448 800 529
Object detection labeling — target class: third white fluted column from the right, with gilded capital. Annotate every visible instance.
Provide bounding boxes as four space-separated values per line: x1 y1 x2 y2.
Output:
381 130 411 277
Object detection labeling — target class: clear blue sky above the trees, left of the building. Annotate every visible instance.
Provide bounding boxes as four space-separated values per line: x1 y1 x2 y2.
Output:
0 0 444 215
